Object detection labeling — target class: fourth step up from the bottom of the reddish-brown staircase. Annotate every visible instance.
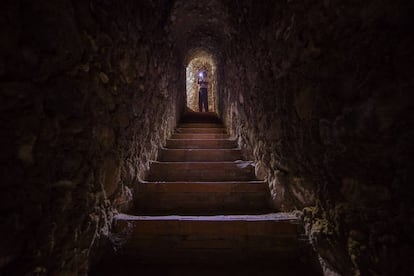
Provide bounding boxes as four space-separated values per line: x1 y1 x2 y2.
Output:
158 148 243 162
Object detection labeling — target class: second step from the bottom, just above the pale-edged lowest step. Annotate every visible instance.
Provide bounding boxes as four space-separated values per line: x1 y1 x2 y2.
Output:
135 181 271 214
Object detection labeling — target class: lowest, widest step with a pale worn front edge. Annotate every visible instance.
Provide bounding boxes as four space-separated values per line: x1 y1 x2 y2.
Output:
114 213 301 263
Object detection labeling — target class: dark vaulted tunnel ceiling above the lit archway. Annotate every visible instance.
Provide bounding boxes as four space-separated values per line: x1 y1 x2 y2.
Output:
169 0 233 58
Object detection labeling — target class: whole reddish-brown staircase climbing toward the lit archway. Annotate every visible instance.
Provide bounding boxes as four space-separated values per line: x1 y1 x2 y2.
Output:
90 113 318 275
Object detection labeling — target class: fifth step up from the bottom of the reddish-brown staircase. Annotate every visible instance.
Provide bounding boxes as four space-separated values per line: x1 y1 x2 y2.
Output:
166 139 237 149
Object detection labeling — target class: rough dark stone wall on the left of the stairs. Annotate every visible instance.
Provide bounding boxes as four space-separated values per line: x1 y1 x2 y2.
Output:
0 0 185 275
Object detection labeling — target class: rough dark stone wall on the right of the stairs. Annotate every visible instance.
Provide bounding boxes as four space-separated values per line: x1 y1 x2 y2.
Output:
220 0 414 275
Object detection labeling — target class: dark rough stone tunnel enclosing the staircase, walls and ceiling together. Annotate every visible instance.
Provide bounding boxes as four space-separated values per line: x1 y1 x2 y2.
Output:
0 0 414 276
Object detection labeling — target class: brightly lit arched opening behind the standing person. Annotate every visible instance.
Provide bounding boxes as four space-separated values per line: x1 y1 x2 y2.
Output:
186 50 218 113
